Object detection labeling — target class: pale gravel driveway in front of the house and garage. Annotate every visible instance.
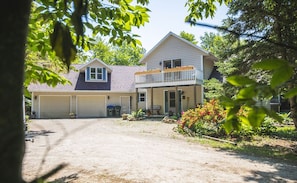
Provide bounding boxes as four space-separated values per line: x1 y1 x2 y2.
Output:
23 118 297 183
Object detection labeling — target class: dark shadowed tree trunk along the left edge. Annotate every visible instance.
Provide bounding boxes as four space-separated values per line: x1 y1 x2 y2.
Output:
0 0 31 183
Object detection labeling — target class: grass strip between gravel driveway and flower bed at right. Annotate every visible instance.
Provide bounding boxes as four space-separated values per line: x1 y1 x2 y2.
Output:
190 125 297 165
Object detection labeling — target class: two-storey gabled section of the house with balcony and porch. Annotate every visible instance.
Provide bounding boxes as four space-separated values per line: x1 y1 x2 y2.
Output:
135 32 217 115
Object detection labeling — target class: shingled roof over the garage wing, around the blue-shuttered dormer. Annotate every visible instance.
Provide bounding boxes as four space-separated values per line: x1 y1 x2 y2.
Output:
28 64 145 92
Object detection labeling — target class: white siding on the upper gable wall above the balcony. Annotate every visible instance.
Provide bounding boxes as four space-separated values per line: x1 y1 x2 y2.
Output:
145 36 203 70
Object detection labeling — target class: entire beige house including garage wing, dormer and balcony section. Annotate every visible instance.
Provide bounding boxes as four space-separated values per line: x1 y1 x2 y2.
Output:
28 32 216 118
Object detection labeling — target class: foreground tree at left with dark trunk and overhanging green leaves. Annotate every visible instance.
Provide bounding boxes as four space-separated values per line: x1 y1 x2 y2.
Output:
0 0 148 183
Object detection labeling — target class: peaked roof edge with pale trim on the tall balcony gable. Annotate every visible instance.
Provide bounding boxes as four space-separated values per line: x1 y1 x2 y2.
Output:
139 32 216 63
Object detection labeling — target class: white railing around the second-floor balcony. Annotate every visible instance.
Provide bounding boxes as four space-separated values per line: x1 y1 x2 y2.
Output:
135 69 203 86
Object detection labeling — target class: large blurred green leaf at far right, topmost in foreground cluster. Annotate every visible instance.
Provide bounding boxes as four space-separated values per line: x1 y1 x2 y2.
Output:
270 65 293 88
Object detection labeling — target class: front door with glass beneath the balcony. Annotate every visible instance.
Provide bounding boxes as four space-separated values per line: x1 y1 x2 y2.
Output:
164 90 181 115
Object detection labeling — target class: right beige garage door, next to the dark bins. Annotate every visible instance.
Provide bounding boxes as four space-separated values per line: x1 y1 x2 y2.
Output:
77 96 106 118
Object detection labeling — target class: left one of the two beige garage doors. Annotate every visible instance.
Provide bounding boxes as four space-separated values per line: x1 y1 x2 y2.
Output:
40 96 70 118
